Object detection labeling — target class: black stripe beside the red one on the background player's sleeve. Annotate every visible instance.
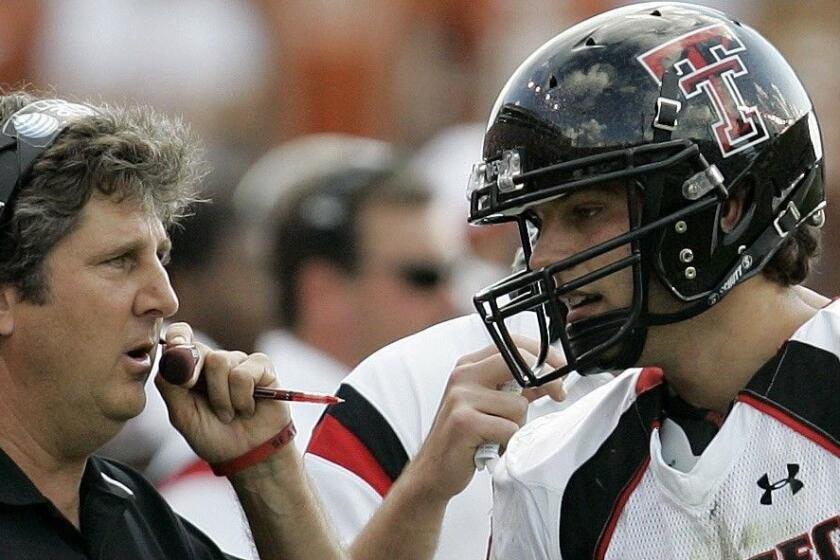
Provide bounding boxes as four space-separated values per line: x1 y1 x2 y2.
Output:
313 384 408 480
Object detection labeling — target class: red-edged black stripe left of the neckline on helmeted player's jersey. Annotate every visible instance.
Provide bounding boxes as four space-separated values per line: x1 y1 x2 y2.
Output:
560 370 667 558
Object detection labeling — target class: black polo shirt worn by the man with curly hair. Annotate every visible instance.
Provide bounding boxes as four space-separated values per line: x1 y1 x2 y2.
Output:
0 450 243 560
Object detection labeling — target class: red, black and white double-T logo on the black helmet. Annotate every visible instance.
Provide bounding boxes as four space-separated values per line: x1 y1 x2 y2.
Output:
637 24 768 158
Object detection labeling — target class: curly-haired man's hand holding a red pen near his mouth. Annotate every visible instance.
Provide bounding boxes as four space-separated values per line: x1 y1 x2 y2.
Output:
155 323 291 463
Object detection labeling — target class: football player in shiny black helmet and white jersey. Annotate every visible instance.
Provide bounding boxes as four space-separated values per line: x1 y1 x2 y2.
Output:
470 3 840 560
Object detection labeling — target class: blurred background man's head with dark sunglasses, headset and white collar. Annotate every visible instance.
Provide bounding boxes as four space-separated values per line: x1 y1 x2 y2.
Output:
257 145 455 444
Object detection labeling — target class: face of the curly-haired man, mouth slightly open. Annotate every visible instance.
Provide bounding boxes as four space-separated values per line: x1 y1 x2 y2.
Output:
3 196 178 446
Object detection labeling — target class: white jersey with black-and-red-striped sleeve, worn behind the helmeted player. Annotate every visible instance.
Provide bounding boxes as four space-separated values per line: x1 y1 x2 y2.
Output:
305 315 612 560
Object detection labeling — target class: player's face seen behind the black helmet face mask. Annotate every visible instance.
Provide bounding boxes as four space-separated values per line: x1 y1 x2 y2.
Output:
531 185 633 323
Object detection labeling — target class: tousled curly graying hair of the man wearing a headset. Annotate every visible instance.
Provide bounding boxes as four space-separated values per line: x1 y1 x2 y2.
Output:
0 91 206 304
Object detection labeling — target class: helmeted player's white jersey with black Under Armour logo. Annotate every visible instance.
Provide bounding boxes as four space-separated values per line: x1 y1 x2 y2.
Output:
491 301 840 560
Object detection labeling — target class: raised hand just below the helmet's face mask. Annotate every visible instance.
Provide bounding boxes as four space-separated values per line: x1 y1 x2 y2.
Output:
412 337 566 500
